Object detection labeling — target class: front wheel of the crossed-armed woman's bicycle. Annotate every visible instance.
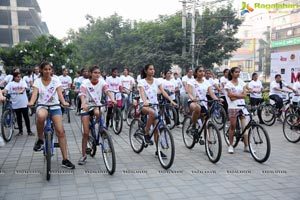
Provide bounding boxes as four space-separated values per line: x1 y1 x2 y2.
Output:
248 124 271 163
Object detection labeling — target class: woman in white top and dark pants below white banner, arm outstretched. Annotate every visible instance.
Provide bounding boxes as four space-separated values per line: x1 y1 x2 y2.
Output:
269 74 297 116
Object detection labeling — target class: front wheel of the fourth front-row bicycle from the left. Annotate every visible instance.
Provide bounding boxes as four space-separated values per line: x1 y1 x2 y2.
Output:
204 121 222 163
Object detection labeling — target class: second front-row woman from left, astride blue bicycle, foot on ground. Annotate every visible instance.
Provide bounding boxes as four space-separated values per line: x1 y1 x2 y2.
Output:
78 66 116 165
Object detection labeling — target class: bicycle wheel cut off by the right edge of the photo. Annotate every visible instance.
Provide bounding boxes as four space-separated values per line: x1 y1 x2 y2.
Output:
282 114 300 143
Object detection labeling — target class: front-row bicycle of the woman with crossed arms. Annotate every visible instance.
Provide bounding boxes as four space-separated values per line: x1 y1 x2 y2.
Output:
224 105 271 163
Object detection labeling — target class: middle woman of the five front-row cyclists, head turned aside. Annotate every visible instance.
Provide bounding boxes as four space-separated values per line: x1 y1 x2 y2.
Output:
138 64 177 148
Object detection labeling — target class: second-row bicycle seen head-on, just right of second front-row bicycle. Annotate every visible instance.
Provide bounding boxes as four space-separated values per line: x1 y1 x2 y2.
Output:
109 91 123 135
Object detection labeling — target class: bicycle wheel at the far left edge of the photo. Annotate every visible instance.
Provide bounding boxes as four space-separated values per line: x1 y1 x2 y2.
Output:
1 110 14 142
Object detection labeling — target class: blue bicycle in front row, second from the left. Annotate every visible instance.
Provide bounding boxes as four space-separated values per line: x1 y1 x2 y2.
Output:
86 104 116 175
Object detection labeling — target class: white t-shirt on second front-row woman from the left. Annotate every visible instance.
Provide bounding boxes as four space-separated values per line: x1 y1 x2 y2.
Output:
79 79 108 106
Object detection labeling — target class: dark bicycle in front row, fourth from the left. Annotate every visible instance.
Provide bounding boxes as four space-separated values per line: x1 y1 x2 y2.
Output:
182 100 222 163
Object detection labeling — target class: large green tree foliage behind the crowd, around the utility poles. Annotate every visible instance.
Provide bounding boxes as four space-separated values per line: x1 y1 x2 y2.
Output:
68 6 241 72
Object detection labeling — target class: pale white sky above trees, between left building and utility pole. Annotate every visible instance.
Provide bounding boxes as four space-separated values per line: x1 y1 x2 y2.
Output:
37 0 182 39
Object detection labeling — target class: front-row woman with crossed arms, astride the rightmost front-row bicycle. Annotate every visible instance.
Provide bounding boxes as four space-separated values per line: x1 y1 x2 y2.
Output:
225 67 249 153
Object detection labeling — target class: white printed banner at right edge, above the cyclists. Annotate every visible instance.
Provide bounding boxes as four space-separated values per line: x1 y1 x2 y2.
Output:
270 51 300 85
